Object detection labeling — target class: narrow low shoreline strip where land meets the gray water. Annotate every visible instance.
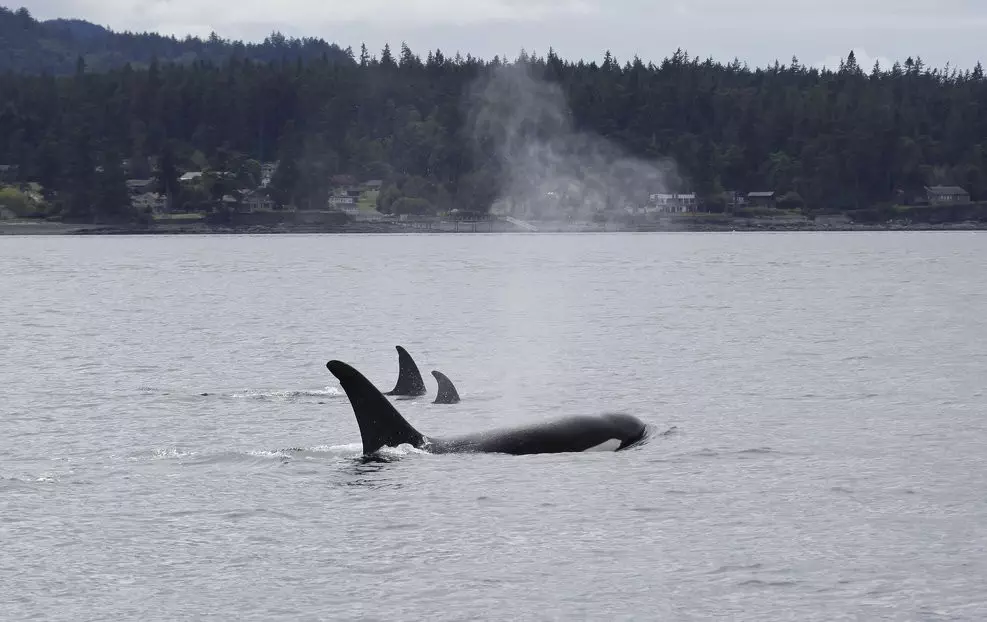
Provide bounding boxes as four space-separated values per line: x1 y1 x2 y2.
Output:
0 220 987 236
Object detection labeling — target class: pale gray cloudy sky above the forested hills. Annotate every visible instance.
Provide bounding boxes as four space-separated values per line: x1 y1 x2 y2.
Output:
21 0 987 69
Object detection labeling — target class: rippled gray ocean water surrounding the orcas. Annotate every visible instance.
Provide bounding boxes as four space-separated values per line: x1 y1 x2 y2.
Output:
0 232 987 620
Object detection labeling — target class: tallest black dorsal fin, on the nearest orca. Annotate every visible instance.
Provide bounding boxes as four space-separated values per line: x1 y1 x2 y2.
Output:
326 361 425 455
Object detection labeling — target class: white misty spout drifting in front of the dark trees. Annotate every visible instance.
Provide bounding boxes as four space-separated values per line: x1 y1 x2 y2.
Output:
467 63 679 221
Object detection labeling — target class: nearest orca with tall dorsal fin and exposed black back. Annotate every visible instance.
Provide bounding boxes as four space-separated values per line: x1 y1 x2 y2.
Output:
326 360 647 456
